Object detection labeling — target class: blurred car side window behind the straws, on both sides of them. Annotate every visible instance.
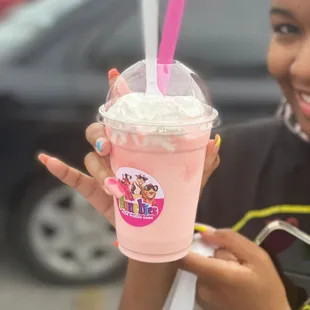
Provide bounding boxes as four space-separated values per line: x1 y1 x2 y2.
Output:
92 0 270 70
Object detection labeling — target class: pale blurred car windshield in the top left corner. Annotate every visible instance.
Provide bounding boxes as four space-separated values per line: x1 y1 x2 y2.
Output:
0 0 89 60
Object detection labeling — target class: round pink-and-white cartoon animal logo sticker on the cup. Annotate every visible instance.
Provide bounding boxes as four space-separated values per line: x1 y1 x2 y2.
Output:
116 167 164 227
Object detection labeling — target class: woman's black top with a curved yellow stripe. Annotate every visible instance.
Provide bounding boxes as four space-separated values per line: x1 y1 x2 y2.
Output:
197 118 310 309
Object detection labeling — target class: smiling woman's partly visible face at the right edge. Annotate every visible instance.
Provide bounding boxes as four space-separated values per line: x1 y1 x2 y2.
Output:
268 0 310 136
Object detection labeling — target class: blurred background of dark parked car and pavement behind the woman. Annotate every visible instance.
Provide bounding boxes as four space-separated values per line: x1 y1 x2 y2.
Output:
0 0 310 310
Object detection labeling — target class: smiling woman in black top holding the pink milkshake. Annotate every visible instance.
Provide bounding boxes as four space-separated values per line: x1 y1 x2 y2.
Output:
37 0 310 310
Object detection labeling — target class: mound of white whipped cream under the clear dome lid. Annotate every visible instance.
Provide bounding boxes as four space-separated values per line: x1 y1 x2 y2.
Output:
107 93 208 125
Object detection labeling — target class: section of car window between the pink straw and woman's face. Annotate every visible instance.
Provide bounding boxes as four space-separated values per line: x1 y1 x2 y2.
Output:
173 0 270 66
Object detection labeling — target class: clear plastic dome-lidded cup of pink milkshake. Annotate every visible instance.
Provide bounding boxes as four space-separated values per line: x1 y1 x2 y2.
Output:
99 61 218 262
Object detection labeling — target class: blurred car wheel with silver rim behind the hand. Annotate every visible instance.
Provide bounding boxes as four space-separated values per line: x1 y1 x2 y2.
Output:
12 176 125 284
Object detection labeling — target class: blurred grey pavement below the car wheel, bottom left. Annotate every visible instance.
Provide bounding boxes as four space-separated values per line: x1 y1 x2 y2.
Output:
0 255 122 310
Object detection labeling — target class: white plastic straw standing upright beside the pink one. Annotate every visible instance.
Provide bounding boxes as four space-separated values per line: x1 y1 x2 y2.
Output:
142 0 161 95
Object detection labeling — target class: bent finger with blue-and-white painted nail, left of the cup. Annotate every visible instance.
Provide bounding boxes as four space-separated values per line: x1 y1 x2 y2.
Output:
86 123 111 156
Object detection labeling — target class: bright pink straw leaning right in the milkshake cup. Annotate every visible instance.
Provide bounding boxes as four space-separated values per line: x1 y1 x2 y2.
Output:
158 0 186 95
